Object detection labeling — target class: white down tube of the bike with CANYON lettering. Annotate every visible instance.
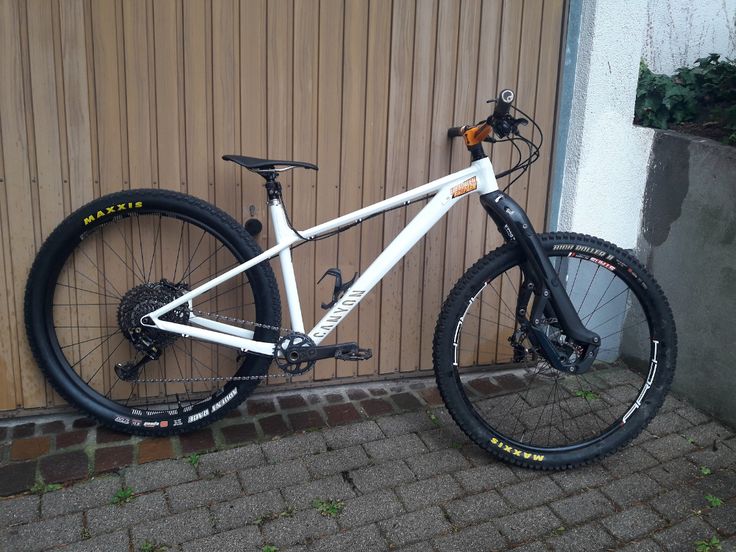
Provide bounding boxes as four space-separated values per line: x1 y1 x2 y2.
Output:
309 189 454 344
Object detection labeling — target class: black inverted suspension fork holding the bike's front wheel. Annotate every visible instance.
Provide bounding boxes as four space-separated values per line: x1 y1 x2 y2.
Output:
480 190 601 372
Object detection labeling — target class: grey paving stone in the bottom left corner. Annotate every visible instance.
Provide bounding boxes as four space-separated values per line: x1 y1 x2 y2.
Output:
3 512 82 552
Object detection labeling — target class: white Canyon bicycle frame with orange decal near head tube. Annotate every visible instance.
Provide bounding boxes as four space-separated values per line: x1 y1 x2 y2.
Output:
141 158 498 355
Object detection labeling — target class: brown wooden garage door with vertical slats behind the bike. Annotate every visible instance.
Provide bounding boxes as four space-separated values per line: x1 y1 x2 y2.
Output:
0 0 564 410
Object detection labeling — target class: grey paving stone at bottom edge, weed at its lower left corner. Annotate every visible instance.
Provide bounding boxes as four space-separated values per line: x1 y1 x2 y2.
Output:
130 508 212 550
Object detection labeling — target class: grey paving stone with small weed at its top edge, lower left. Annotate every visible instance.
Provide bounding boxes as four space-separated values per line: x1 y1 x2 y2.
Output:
87 492 169 535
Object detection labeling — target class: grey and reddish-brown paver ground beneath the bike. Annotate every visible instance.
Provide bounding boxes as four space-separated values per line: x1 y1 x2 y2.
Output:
0 382 736 552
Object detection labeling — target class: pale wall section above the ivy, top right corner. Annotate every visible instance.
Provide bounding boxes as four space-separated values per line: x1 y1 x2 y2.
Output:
642 0 736 75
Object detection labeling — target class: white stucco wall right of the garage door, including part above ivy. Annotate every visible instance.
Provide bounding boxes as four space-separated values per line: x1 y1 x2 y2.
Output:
550 0 736 248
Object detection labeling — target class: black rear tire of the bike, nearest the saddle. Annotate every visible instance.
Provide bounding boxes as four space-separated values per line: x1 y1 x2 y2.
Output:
25 189 281 435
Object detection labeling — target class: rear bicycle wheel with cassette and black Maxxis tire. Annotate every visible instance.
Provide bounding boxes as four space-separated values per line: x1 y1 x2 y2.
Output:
25 190 281 435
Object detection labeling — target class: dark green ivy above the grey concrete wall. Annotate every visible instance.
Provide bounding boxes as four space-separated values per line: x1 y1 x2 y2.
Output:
634 54 736 145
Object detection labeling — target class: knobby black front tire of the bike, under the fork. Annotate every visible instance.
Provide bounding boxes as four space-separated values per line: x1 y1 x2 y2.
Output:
433 233 677 470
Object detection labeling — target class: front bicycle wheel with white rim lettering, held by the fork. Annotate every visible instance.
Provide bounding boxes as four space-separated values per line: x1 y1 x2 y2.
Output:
434 233 676 469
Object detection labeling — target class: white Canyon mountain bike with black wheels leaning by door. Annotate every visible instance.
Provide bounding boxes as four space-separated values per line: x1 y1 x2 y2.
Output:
25 90 676 469
